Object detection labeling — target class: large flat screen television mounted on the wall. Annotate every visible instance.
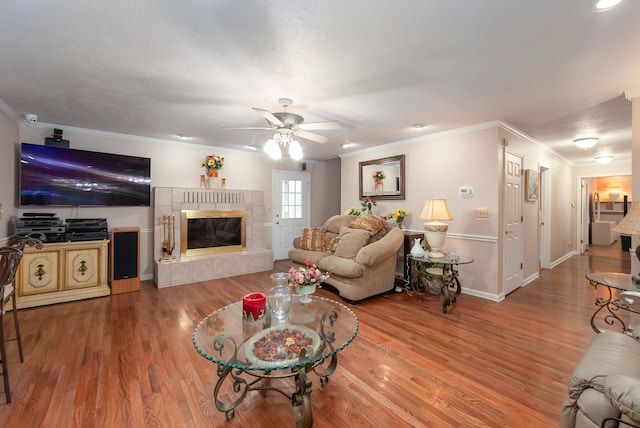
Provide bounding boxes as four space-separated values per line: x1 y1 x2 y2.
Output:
20 143 151 207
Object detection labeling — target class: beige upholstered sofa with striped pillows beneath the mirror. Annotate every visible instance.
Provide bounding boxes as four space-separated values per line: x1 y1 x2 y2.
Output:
289 215 404 302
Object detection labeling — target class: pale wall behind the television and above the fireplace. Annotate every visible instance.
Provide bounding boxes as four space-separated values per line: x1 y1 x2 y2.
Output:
7 122 340 279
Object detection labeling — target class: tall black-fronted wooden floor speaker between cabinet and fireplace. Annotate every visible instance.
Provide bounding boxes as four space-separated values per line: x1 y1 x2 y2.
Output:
109 227 140 294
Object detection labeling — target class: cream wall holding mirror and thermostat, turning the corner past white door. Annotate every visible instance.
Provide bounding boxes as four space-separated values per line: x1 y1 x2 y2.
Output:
341 122 575 300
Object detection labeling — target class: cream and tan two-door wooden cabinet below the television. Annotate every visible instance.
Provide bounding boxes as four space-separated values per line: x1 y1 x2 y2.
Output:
16 240 111 308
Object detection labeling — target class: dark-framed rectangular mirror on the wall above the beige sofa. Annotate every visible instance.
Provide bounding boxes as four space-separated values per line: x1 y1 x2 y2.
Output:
360 155 405 200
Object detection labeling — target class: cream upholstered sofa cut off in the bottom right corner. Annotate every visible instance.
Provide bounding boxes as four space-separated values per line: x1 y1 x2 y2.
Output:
560 331 640 428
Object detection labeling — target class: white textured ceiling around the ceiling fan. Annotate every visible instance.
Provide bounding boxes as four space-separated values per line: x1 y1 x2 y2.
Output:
0 0 640 163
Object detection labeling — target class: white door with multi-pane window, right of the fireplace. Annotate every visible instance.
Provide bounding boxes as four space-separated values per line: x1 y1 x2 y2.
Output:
271 171 311 260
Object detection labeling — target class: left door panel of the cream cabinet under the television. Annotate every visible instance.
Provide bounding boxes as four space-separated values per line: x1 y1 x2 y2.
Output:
18 250 61 296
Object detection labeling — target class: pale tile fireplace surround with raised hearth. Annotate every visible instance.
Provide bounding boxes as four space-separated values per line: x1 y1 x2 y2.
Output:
153 187 273 288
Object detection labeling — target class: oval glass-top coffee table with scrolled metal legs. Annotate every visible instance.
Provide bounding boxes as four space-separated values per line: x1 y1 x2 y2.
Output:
193 294 358 427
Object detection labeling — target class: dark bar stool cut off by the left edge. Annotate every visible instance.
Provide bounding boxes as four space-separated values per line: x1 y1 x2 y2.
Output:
0 247 24 404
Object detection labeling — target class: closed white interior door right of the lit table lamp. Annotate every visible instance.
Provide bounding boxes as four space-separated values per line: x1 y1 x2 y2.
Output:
502 152 523 296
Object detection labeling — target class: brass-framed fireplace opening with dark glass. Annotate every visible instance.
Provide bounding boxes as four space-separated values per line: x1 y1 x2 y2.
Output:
180 210 246 257
